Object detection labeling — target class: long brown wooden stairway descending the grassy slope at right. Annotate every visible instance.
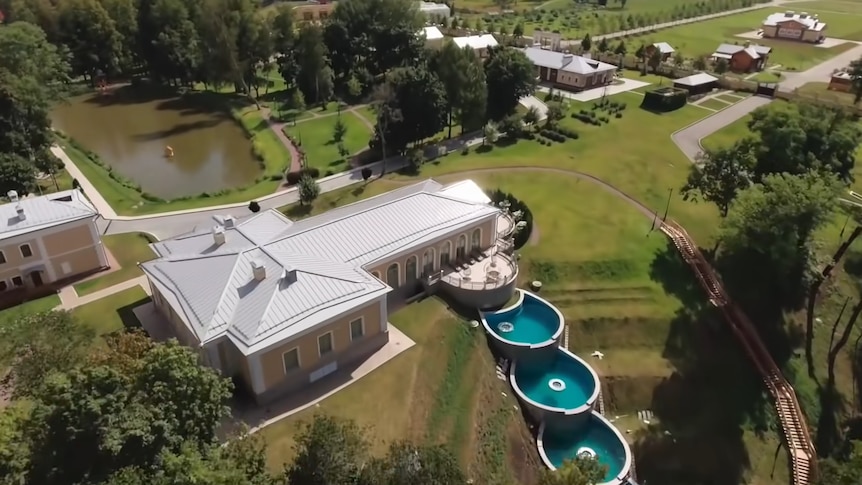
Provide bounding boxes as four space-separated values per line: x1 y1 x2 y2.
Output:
661 222 817 485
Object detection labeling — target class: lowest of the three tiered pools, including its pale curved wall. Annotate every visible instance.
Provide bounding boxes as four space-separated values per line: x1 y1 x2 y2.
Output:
536 411 633 485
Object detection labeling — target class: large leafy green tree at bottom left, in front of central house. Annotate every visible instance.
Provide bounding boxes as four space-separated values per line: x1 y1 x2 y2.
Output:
27 341 232 483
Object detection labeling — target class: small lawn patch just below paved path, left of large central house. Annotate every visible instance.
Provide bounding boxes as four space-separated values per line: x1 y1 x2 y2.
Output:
72 286 149 335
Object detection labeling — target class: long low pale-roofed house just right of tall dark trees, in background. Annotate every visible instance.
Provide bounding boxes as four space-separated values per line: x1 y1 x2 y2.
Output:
524 47 617 91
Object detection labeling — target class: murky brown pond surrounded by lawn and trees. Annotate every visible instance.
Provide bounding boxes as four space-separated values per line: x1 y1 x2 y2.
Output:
51 86 261 199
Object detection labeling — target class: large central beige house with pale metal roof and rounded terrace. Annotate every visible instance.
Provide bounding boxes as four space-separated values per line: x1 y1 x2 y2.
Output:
141 180 518 402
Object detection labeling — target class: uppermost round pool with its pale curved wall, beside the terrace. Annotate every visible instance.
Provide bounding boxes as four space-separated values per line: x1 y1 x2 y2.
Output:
482 289 565 361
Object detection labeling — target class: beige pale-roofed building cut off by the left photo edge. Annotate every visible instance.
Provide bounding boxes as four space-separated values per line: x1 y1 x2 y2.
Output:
0 190 108 306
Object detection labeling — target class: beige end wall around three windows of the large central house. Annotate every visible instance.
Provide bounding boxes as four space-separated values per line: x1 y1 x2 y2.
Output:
260 300 385 390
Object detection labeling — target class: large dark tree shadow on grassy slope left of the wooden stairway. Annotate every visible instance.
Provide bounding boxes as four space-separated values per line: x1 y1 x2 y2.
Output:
633 243 778 485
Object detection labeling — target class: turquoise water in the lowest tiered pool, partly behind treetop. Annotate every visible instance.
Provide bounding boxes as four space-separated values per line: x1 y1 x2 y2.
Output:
542 416 627 482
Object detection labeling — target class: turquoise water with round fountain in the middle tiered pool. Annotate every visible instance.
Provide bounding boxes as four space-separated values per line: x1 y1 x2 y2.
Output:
514 350 596 409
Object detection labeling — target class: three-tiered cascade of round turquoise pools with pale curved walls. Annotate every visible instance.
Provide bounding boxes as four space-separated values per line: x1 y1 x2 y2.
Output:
481 289 633 485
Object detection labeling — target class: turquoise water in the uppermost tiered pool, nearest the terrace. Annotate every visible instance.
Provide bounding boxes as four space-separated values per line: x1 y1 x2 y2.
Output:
484 293 563 344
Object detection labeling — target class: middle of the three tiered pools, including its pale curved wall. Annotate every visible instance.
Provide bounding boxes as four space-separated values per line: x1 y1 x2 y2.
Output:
509 347 600 429
